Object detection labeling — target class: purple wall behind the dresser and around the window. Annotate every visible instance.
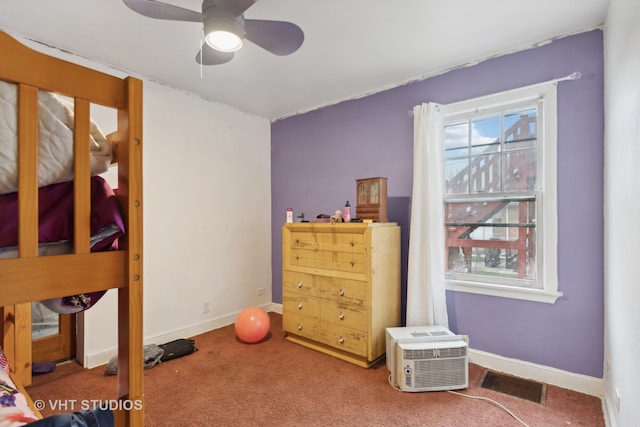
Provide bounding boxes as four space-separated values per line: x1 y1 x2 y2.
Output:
271 30 604 377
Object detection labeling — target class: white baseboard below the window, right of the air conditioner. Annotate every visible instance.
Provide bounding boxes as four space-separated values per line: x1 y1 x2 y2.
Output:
469 349 604 399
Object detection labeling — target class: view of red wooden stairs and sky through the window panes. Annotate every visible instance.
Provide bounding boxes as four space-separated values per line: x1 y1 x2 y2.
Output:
443 106 538 284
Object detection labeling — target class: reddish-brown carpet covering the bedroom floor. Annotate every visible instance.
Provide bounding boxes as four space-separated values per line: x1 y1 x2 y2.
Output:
27 313 605 427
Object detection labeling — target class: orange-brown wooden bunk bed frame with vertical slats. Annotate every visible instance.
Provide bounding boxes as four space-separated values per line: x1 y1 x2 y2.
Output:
0 31 144 426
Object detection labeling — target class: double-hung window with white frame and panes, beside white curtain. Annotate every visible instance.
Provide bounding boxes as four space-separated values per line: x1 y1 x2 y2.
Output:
443 84 561 303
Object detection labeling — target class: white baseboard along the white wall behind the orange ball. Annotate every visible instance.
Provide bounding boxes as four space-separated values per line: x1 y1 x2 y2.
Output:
83 303 282 368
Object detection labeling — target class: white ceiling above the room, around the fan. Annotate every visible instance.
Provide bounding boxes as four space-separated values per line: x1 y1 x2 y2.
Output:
0 0 609 120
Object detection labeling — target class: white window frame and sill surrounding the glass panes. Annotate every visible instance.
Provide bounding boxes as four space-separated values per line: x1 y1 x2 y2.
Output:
443 82 562 304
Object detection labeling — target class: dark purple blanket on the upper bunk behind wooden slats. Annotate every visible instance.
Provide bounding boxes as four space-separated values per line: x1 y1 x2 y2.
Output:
0 176 125 313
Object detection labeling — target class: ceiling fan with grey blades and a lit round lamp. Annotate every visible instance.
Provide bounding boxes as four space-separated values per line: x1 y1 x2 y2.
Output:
123 0 304 65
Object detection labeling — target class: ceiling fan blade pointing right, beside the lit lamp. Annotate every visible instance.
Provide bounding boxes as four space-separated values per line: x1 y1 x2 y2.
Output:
244 19 304 56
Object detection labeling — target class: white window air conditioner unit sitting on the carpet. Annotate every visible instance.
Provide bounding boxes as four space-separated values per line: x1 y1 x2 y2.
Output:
386 326 469 392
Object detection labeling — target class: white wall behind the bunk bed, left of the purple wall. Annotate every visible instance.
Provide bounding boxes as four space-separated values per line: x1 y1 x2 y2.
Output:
81 81 271 367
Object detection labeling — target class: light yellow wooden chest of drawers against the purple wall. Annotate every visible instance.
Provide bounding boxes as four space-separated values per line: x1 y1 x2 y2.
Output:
282 222 400 367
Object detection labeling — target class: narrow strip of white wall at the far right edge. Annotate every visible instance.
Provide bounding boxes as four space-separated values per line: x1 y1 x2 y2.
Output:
604 0 640 427
